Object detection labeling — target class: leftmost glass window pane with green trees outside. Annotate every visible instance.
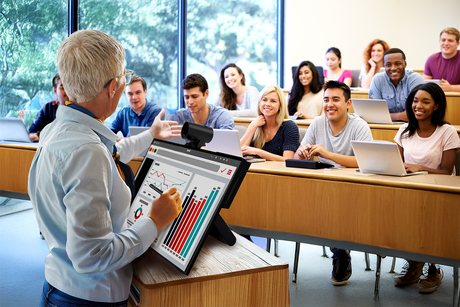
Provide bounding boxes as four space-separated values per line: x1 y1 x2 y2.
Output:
0 0 67 127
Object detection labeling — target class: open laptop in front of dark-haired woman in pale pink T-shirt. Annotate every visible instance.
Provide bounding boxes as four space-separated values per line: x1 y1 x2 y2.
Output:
351 141 427 176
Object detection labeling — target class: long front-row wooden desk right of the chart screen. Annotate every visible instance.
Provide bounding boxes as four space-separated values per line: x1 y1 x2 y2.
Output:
221 162 460 267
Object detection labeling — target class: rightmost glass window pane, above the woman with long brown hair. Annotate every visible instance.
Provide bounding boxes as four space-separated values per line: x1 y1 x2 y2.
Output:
187 0 277 104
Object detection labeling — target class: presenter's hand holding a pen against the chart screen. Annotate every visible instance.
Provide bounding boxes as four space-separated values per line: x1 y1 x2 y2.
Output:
149 187 182 231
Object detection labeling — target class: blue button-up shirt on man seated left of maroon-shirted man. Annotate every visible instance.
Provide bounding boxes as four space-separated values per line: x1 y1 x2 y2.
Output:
369 70 423 113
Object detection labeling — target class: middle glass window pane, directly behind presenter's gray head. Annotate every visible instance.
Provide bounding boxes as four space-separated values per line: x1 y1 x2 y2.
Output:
79 0 178 124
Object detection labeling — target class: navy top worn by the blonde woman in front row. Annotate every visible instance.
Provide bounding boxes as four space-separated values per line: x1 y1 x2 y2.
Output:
251 120 300 156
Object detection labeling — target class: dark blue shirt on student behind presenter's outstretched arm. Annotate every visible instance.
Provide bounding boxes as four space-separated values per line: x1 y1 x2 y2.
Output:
110 102 161 137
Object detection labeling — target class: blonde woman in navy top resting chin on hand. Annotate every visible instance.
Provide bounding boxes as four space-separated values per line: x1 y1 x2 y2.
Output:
240 85 300 161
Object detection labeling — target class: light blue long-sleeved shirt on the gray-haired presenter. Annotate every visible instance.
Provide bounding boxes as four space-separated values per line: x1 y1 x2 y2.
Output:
28 106 157 302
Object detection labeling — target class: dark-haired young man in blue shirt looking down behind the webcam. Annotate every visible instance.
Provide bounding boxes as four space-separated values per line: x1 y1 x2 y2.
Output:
171 74 235 130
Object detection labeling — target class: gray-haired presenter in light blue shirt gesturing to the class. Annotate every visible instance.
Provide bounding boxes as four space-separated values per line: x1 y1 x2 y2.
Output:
28 30 182 306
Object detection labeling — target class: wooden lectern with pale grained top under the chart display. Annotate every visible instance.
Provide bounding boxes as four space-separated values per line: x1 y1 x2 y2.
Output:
133 234 289 307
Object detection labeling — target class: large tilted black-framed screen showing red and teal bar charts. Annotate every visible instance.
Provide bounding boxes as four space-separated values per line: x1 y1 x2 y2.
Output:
128 140 250 274
